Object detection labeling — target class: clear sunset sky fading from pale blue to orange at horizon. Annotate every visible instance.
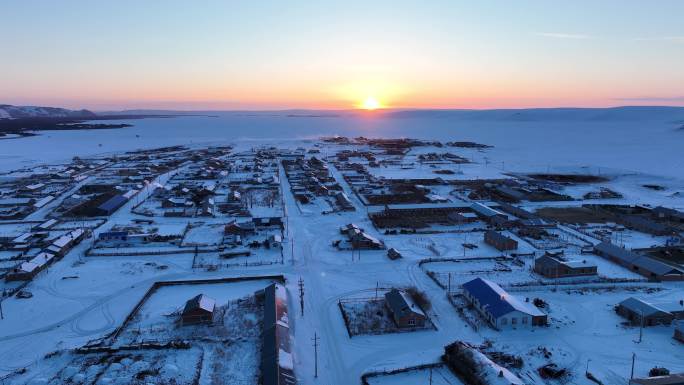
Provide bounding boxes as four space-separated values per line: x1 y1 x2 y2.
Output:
0 0 684 110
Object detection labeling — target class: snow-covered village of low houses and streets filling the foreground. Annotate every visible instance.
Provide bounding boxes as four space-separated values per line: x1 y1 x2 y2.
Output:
0 136 684 385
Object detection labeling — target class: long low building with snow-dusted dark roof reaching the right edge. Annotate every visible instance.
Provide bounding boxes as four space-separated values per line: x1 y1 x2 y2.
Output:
594 242 684 281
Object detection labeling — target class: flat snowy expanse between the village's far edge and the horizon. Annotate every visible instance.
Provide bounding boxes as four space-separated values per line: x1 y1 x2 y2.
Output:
0 111 684 179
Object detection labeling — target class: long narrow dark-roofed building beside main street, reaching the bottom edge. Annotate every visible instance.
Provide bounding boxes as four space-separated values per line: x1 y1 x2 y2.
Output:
258 283 297 385
